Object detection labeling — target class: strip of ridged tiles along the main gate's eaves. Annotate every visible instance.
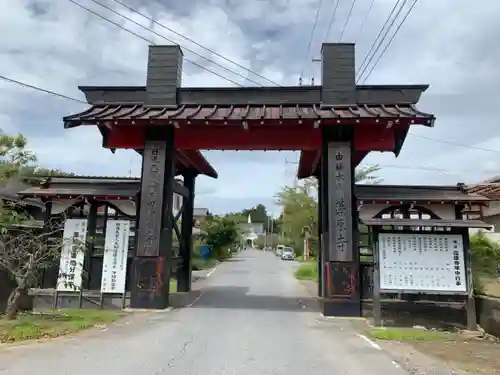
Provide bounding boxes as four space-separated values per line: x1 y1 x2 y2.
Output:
63 103 434 128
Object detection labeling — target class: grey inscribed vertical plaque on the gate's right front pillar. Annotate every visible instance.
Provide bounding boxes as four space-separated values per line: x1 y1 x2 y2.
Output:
328 142 354 262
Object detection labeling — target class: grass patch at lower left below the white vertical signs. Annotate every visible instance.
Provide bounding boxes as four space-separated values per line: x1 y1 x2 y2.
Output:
0 309 125 343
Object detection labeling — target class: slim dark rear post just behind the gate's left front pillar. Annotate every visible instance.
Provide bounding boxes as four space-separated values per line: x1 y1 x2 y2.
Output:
177 173 196 292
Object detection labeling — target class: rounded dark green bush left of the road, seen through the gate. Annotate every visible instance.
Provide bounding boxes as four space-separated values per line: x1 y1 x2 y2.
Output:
201 216 239 259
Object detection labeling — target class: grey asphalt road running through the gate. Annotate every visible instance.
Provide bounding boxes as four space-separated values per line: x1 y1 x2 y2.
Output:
0 250 406 375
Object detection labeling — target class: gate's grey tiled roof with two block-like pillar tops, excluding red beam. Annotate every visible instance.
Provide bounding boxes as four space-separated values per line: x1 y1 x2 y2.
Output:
64 43 434 127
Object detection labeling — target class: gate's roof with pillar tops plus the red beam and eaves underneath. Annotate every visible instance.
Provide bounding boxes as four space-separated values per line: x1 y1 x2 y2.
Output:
64 43 435 177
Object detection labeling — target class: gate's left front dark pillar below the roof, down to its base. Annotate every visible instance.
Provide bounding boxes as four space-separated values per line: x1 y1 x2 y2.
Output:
130 126 175 309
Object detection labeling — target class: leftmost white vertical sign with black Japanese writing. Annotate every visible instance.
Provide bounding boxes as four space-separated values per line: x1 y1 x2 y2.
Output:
57 219 87 292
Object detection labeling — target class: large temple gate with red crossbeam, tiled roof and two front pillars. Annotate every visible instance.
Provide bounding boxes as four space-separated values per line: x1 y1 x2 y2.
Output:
64 43 434 316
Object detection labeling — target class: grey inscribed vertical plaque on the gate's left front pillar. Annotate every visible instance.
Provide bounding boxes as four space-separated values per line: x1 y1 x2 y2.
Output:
137 141 167 256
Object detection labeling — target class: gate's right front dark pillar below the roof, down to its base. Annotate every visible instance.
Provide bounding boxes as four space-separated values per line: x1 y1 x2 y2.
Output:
320 126 361 316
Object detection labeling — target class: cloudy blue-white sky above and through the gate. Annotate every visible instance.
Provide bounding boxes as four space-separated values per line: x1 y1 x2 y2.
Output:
0 0 500 213
